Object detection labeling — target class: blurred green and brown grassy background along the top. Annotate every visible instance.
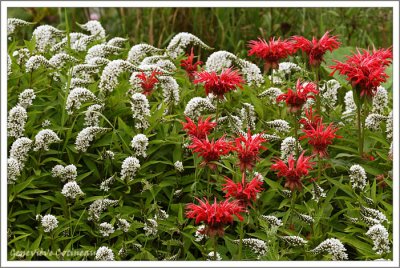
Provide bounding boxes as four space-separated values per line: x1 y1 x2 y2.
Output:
8 8 393 56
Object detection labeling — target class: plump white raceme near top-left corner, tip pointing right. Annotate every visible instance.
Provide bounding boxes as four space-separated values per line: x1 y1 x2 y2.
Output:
32 25 64 53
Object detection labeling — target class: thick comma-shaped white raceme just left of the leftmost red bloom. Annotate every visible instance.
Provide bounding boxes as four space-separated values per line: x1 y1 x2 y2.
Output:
99 60 138 93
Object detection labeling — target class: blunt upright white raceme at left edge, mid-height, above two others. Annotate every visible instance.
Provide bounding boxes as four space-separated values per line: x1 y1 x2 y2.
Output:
7 105 28 138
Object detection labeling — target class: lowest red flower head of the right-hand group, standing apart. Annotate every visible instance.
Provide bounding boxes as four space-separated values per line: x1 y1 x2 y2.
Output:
271 151 315 191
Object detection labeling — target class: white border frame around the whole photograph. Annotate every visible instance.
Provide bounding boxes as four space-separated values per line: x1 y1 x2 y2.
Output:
1 0 400 267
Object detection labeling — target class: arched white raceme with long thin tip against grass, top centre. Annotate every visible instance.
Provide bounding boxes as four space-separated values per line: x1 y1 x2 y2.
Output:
167 32 212 59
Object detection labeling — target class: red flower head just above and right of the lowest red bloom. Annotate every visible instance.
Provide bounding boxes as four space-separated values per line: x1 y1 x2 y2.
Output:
222 173 263 207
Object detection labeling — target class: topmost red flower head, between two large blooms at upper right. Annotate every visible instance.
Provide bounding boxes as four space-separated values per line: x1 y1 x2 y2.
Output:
292 32 340 66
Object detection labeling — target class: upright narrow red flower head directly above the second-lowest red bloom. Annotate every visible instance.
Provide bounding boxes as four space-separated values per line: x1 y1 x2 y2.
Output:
233 129 267 172
